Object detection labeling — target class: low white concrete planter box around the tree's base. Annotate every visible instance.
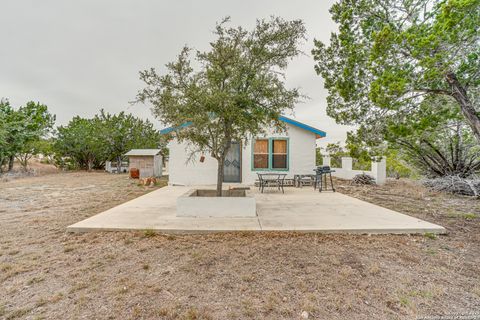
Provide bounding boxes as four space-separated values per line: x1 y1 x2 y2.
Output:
177 189 257 218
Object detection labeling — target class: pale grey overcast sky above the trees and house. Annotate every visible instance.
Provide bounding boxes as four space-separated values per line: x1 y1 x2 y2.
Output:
0 0 347 144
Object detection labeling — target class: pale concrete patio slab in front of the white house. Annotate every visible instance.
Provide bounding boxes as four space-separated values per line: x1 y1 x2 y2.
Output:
67 186 445 234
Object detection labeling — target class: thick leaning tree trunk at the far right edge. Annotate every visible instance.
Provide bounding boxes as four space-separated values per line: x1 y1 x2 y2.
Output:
445 72 480 143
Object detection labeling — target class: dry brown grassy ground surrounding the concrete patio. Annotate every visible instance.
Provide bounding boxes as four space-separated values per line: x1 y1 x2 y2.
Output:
0 172 480 319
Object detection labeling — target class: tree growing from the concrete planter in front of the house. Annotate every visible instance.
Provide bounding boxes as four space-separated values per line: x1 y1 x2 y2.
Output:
137 17 305 196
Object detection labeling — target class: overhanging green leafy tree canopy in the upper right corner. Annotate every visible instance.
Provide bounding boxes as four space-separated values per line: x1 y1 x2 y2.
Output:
313 0 480 143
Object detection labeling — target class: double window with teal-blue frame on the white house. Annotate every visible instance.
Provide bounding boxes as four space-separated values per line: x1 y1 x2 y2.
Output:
252 138 288 170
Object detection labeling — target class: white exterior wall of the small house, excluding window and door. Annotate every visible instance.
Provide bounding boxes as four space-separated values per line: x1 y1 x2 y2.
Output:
168 124 316 185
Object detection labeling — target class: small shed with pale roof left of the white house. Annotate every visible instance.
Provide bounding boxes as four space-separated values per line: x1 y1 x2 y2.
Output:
125 149 163 178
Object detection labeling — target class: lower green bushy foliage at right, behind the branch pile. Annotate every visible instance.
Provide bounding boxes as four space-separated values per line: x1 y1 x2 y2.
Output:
348 96 480 177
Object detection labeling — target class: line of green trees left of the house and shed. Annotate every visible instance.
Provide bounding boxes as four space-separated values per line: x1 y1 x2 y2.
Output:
0 99 167 173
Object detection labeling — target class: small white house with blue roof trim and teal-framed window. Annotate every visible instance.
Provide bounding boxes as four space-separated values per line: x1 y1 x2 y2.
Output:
161 116 326 185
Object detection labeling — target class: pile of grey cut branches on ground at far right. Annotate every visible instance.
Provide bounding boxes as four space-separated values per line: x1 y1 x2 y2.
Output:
422 176 480 197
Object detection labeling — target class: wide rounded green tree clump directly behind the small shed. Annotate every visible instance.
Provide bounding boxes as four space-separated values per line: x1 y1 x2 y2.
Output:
54 110 166 170
